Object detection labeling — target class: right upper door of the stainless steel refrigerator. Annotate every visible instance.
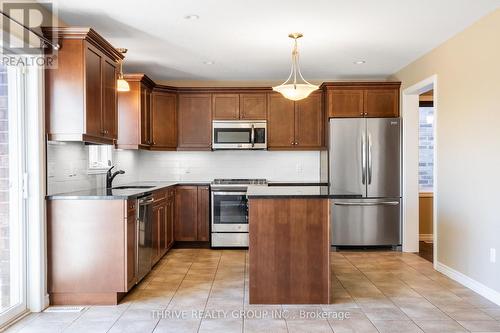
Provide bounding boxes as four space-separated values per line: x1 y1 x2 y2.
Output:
366 118 401 198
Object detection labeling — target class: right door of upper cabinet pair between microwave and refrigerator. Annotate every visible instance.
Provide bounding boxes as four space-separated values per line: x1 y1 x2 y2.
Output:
295 93 325 149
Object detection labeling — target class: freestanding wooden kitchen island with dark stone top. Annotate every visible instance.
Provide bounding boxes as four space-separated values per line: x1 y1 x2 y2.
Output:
247 186 360 304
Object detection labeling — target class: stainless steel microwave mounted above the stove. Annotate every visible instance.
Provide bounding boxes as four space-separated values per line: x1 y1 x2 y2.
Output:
212 120 267 149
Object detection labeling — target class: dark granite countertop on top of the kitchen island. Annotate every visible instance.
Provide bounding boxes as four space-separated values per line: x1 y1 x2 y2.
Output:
247 185 362 199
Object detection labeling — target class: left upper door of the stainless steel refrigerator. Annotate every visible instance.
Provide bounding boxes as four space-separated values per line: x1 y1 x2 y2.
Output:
329 118 367 196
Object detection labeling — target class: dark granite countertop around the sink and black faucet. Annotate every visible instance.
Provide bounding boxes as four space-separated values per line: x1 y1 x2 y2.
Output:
46 181 210 200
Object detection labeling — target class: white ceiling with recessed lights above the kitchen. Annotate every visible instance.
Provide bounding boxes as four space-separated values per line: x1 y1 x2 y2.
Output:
46 0 500 81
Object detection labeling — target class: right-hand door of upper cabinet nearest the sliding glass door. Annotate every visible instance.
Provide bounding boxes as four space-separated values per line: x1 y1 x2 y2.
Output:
102 58 118 139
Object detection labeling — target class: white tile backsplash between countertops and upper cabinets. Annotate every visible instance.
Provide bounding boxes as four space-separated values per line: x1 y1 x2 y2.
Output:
47 142 320 194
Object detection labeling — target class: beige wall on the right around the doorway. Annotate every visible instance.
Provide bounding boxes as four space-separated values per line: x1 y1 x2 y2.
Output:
393 10 500 292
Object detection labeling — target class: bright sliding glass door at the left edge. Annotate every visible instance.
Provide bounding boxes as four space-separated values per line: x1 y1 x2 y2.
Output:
0 63 27 326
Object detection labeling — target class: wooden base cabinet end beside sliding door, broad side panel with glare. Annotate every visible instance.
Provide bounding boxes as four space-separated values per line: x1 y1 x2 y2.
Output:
47 200 137 305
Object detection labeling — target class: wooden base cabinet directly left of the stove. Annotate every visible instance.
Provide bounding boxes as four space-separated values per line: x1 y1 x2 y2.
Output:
174 186 210 242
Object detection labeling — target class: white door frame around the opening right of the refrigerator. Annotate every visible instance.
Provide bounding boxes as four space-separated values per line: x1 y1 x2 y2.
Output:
401 75 438 265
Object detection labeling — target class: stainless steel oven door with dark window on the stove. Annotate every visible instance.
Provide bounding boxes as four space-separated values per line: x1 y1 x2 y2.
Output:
212 191 248 232
